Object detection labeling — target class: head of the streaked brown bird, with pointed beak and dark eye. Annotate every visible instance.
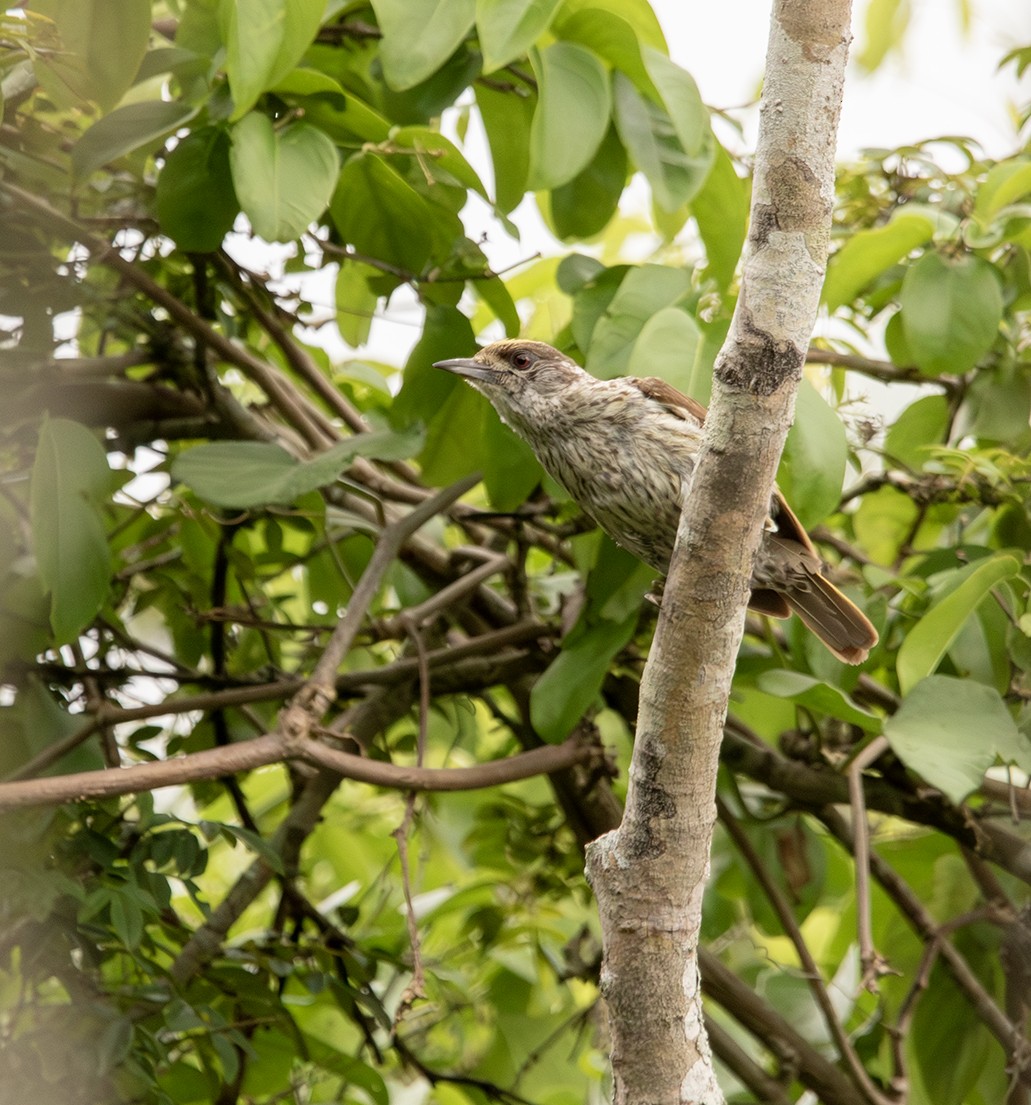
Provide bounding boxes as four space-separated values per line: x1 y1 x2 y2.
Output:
434 339 590 421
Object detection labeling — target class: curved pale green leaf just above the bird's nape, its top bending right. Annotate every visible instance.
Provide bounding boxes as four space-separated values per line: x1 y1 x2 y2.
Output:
581 265 691 379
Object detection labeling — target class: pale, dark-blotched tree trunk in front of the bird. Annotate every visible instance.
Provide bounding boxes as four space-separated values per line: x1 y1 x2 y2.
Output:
588 0 850 1105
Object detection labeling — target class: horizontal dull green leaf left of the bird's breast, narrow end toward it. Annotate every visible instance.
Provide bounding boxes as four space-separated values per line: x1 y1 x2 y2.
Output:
171 429 422 509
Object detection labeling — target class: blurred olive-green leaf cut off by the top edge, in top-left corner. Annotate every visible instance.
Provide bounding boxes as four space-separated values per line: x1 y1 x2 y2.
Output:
32 0 150 112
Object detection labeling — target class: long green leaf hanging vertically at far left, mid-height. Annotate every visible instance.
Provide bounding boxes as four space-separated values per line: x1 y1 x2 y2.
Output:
29 418 113 644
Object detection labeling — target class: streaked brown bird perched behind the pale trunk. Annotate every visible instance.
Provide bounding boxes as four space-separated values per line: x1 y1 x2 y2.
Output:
434 338 877 664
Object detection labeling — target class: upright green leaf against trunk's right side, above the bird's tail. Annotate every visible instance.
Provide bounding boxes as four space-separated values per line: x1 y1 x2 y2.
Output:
777 378 849 528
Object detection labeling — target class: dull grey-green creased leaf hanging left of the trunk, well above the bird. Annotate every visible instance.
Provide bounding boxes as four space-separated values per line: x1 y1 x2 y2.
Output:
612 73 715 212
